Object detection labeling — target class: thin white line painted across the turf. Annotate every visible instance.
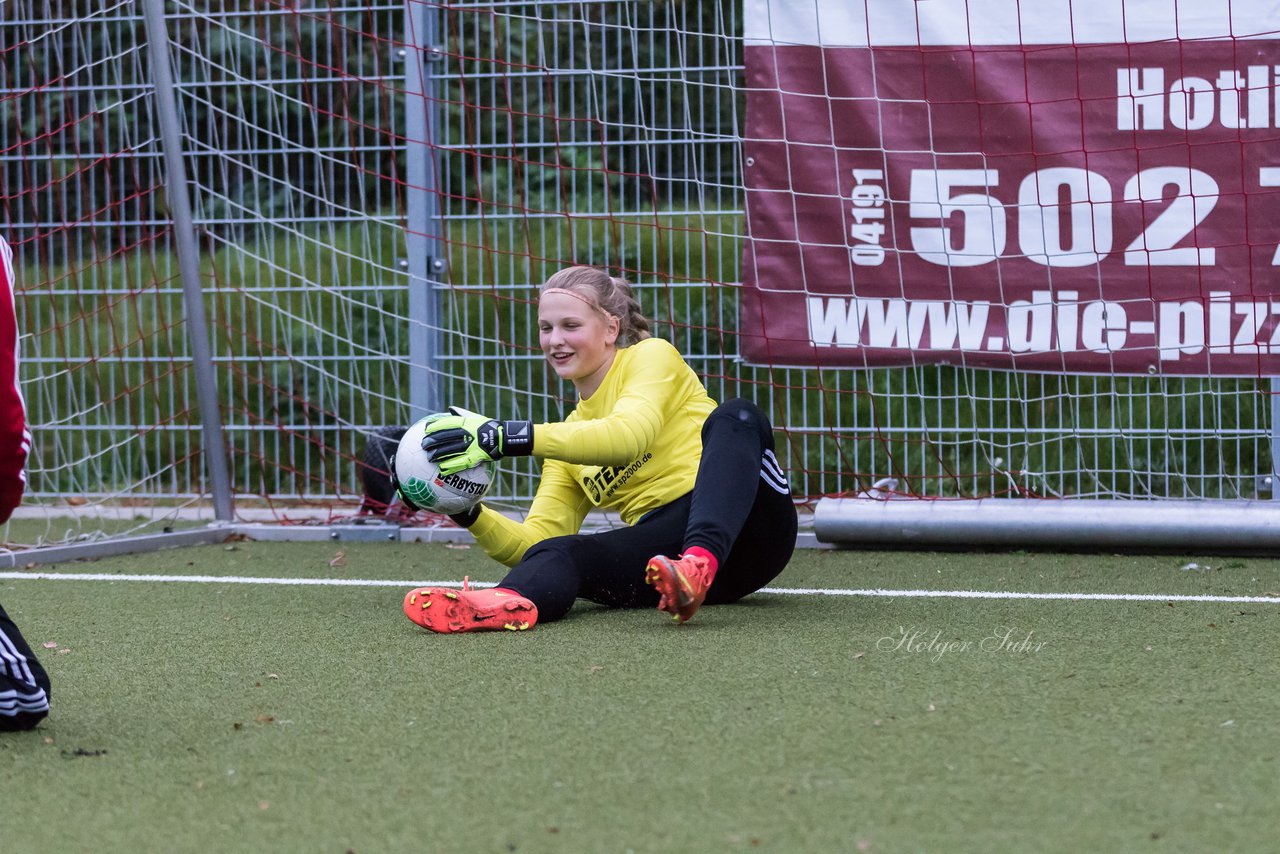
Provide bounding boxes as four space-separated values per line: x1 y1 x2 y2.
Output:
0 571 1280 604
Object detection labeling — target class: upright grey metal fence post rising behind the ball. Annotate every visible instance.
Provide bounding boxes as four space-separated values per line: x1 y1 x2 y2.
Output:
404 0 448 420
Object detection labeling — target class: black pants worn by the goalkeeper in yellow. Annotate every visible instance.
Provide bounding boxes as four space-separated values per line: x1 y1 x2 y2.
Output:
500 399 796 622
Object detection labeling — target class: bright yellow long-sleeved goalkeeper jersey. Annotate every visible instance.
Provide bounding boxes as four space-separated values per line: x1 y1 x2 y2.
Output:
470 338 716 566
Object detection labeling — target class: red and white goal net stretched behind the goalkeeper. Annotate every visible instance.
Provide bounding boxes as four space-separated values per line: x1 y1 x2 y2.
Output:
0 0 1280 561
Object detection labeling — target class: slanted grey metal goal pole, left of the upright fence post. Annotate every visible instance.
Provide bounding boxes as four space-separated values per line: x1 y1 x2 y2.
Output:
142 0 233 522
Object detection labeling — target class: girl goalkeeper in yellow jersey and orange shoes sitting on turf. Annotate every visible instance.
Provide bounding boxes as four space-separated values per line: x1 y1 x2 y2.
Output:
401 266 796 632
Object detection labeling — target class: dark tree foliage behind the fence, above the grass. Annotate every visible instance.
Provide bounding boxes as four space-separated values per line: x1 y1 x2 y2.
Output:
0 0 741 255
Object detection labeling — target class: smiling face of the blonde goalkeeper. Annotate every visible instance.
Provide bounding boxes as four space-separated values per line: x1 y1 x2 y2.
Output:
538 292 618 398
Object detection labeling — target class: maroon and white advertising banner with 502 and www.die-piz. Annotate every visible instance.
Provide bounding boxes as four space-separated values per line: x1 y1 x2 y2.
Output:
740 0 1280 376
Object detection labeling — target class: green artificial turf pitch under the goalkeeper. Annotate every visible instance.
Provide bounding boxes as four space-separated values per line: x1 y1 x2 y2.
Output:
0 543 1280 851
